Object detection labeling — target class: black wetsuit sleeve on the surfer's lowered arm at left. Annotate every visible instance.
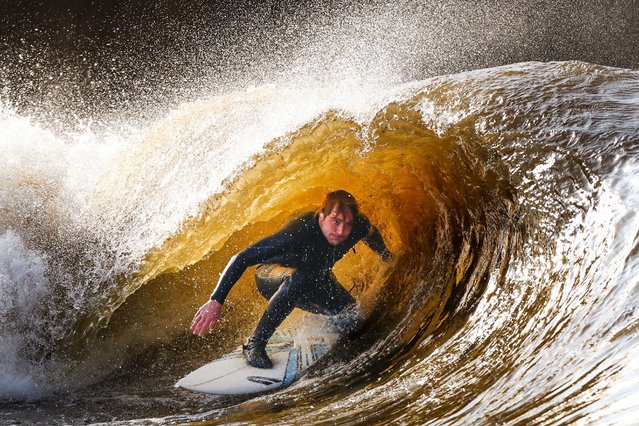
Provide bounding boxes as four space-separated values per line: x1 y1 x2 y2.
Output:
211 227 294 304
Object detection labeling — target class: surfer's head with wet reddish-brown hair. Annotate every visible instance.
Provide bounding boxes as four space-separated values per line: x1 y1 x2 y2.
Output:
319 190 359 245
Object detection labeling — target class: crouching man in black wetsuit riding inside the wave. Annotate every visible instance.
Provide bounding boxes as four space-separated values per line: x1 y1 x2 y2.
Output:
191 190 392 368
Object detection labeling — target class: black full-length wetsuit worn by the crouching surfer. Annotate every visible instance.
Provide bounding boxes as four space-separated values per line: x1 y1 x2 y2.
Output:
211 212 390 345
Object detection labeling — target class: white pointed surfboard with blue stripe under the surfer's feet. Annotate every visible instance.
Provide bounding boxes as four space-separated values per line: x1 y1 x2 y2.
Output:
175 316 339 395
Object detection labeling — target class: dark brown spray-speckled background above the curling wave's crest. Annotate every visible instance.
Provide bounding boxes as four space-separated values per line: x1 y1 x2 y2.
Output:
0 0 639 124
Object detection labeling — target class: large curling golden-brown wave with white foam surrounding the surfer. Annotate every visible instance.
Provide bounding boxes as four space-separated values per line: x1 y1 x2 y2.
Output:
0 62 639 424
